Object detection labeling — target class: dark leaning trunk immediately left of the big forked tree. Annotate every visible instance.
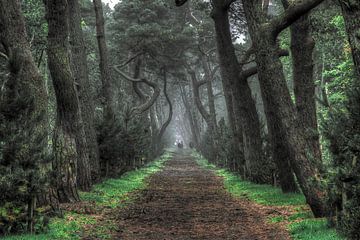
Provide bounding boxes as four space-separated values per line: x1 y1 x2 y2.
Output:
212 1 266 183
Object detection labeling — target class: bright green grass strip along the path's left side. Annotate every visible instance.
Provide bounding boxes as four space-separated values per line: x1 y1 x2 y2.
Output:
3 150 172 240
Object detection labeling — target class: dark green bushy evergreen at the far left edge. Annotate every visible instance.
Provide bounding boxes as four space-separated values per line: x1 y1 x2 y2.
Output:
0 69 50 235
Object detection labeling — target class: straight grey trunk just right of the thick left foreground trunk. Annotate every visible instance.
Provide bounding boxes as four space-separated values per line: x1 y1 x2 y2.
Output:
68 0 100 182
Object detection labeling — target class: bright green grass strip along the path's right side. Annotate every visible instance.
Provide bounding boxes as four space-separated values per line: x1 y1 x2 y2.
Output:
192 152 345 240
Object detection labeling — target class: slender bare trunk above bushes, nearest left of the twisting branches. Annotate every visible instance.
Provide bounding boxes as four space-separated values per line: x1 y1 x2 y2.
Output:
93 0 115 121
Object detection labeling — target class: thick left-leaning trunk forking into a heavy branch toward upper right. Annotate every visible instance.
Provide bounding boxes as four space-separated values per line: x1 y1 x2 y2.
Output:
243 0 327 217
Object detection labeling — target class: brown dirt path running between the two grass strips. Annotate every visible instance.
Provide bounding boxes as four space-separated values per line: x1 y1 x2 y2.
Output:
116 152 290 240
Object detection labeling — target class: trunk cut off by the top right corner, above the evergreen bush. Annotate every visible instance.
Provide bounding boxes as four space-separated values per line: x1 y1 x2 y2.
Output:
340 0 360 81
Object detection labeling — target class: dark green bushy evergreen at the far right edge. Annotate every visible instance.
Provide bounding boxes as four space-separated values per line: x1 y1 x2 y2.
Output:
325 86 360 239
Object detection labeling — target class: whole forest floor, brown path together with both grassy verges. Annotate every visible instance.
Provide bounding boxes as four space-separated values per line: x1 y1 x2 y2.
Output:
4 150 344 240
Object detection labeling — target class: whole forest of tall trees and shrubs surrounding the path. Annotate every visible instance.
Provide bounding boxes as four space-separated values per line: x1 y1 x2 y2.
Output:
0 0 360 239
